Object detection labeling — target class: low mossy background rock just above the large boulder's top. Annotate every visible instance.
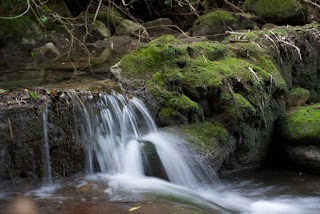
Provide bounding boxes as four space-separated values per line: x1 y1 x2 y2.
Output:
191 10 257 38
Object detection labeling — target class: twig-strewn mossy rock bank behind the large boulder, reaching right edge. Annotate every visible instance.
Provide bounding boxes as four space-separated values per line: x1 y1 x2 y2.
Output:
223 23 320 103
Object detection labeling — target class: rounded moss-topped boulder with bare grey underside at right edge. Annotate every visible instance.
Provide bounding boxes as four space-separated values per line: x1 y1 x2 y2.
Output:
279 104 320 170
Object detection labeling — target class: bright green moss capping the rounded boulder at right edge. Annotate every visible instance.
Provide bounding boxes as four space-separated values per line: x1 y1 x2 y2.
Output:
281 104 320 144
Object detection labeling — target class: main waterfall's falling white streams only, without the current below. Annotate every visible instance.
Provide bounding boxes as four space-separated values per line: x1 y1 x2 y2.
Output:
69 92 219 185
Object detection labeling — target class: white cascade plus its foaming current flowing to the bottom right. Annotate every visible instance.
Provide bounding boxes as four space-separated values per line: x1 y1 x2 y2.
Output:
72 94 320 214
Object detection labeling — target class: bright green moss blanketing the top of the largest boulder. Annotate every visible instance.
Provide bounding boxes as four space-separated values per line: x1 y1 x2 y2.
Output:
121 36 286 121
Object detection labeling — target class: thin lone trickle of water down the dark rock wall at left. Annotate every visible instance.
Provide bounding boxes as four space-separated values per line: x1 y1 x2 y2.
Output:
42 105 52 186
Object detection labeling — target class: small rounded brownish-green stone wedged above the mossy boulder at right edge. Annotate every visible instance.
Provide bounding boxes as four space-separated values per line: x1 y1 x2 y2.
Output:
285 87 310 107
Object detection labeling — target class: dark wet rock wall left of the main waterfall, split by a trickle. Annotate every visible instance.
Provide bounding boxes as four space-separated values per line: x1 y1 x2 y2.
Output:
0 93 84 179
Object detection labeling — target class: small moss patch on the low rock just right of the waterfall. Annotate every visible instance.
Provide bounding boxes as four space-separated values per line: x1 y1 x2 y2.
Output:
181 122 228 150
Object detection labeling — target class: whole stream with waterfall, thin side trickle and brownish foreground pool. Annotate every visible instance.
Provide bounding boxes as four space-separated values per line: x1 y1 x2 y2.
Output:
0 87 320 214
